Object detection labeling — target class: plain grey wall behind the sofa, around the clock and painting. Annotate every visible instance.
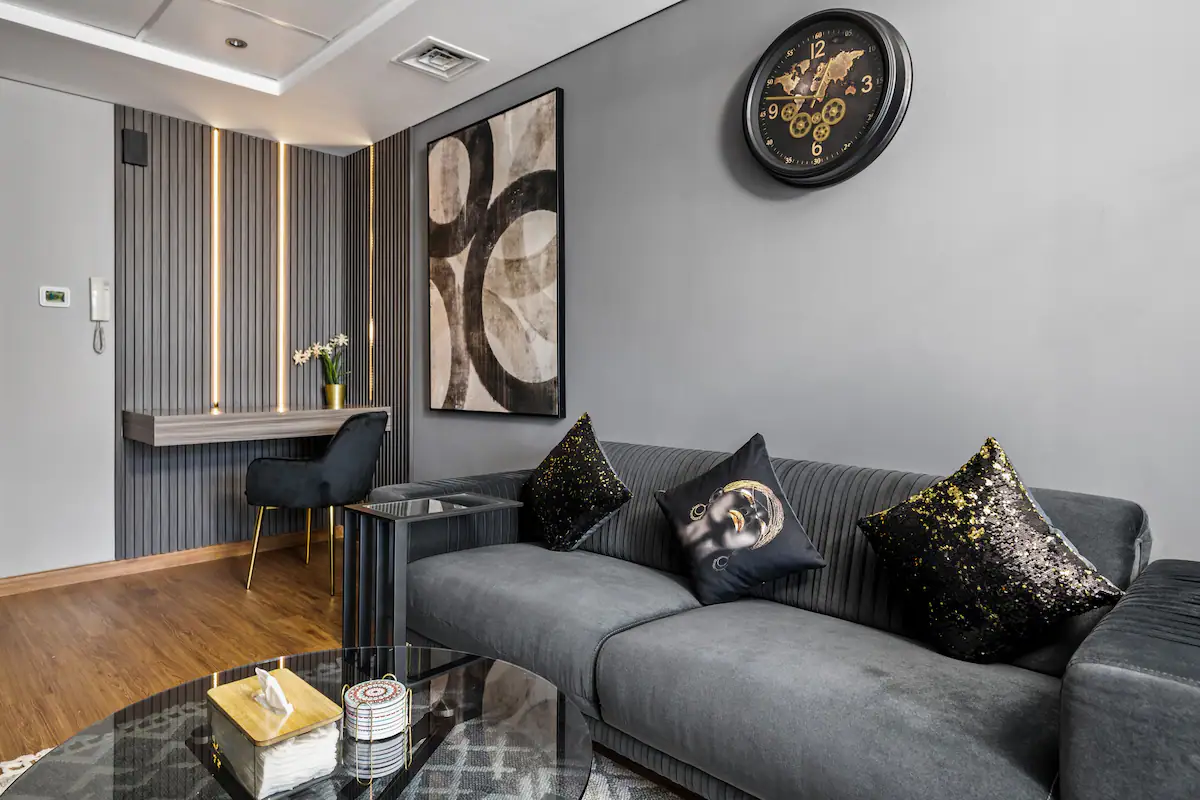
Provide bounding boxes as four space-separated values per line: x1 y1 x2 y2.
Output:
412 0 1200 558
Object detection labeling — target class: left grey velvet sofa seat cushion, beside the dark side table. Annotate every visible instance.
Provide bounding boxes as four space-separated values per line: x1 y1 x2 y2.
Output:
408 543 700 716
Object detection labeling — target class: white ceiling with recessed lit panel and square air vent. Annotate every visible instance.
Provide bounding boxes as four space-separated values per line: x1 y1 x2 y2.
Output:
0 0 678 154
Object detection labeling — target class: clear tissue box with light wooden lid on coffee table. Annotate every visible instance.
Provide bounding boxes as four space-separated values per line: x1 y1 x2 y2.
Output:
209 668 342 800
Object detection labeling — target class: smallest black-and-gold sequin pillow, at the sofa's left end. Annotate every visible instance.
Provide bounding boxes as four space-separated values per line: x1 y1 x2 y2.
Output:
521 414 631 551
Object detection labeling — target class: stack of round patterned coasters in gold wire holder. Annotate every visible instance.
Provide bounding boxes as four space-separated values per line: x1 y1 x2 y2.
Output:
342 679 412 778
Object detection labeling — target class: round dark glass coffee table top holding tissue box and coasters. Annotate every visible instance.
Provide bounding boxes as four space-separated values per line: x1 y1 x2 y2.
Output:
2 646 592 800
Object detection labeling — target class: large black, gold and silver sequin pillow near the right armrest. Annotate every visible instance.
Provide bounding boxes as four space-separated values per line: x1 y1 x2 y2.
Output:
858 439 1122 662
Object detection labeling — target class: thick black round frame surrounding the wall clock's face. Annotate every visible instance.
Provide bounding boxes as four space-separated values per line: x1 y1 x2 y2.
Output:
742 8 912 188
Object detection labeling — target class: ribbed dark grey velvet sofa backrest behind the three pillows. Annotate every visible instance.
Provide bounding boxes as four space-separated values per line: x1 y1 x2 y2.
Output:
583 443 1148 632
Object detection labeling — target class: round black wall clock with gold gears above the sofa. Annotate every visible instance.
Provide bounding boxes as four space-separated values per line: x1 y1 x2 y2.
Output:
744 8 912 187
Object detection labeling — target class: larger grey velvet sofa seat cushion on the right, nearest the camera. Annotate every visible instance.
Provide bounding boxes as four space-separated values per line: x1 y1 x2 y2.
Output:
596 600 1061 800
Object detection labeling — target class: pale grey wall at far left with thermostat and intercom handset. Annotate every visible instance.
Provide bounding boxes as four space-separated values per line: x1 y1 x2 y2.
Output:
0 80 114 578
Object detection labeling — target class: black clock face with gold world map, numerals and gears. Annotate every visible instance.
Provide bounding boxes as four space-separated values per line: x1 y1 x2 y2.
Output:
757 19 888 174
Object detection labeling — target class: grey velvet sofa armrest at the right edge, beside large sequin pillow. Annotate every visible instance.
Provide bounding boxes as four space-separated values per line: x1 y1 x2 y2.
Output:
1060 560 1200 800
